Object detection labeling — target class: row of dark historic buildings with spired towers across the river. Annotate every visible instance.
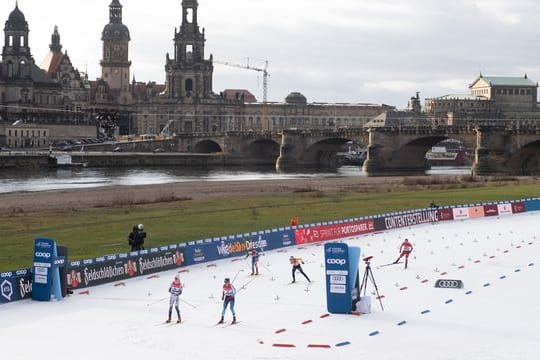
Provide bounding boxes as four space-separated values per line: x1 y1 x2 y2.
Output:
0 0 393 146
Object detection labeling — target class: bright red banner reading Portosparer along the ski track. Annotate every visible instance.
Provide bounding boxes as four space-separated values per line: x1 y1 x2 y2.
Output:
294 219 375 245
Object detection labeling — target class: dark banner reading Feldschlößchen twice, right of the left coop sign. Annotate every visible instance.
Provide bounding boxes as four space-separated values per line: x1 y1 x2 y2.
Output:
67 245 185 289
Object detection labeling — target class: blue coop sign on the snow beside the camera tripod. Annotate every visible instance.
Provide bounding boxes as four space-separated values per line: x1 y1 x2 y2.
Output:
324 243 360 314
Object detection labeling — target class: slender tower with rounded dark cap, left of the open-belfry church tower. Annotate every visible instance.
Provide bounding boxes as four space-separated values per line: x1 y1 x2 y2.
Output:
100 0 131 97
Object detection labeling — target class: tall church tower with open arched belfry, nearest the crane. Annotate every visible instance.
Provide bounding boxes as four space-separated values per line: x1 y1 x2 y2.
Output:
165 0 214 99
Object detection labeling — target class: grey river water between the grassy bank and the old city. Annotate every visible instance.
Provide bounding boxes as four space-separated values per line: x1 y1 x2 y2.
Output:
0 166 470 193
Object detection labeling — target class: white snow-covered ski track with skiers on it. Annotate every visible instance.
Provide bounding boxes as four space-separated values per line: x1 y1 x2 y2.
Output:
0 212 540 360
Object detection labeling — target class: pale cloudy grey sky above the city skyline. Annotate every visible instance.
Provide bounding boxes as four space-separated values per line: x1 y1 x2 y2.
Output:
4 0 540 108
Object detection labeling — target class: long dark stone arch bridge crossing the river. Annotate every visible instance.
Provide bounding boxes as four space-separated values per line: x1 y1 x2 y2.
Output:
108 125 540 175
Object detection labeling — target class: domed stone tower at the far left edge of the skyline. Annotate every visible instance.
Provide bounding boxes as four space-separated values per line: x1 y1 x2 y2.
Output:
2 3 34 78
